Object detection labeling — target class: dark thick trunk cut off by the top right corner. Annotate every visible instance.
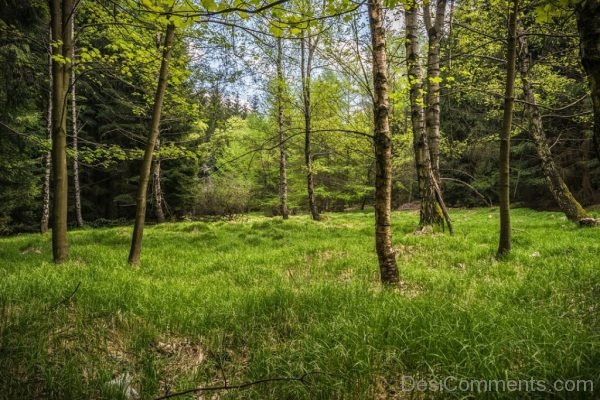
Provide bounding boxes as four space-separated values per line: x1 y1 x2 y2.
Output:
575 0 600 161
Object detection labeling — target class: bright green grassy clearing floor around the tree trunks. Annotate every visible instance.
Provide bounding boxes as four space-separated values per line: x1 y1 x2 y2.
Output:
0 209 600 399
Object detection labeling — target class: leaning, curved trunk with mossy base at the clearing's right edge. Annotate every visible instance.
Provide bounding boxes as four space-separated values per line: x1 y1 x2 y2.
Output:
518 25 587 222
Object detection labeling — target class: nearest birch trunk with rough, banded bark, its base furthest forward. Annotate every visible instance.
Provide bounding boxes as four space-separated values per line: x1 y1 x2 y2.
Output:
368 0 400 286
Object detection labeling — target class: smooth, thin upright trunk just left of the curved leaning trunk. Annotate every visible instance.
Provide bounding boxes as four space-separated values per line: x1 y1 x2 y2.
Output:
497 0 519 258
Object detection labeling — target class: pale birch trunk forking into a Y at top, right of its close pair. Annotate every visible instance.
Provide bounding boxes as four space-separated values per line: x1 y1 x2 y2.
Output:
423 0 446 180
